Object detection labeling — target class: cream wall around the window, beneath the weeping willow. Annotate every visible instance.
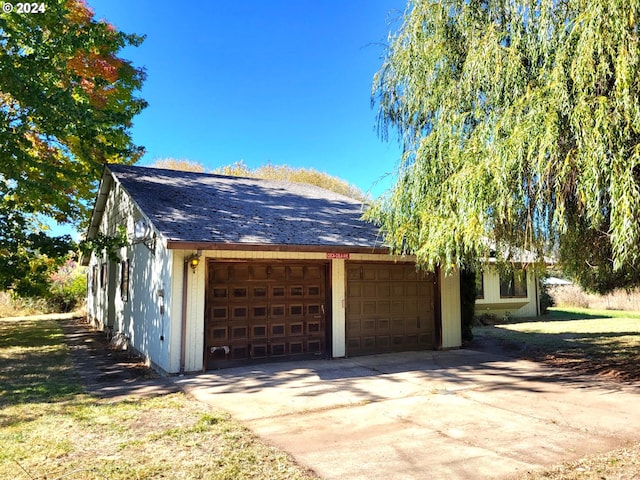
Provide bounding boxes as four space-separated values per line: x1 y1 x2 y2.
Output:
476 265 539 317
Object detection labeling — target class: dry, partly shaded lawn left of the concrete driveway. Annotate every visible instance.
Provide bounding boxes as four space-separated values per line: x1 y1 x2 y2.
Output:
0 320 316 480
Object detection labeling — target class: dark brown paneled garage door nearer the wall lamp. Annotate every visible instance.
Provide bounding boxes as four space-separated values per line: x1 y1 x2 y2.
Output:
205 261 326 368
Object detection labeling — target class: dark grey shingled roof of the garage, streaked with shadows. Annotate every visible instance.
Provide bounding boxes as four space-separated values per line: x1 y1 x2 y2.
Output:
95 165 381 250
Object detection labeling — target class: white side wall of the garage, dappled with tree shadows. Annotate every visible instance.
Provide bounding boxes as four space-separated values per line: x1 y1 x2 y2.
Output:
87 178 173 371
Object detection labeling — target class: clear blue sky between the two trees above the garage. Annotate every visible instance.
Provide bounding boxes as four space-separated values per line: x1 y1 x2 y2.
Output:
87 0 405 197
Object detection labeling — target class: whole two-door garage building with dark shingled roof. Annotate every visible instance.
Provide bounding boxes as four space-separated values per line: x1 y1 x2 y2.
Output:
85 165 461 374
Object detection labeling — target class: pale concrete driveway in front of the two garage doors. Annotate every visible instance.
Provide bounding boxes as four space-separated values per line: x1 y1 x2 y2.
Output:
176 350 640 480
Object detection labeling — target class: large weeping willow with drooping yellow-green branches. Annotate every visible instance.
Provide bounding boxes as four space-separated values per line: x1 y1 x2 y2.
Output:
368 0 640 291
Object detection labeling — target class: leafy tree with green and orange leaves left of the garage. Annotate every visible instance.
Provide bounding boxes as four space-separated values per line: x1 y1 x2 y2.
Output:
0 0 146 291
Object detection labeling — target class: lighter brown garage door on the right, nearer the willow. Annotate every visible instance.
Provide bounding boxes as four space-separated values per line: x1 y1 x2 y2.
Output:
346 262 435 355
